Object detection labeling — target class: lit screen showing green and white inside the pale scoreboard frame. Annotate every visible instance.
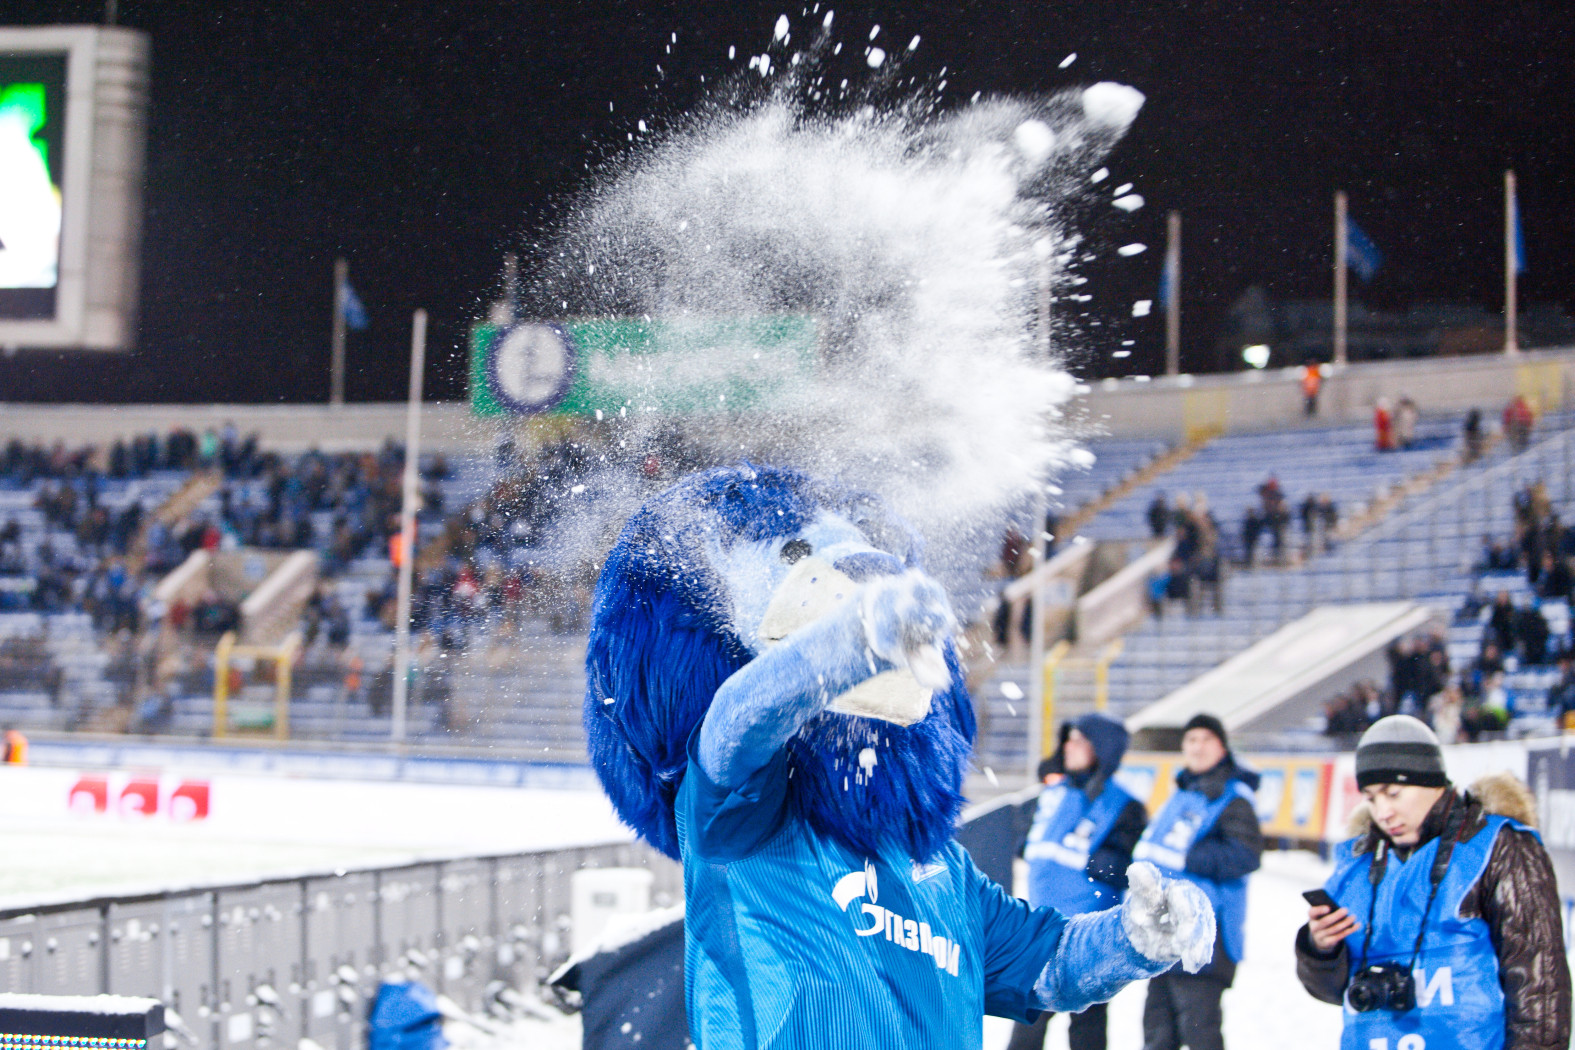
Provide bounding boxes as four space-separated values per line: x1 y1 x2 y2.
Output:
0 54 68 320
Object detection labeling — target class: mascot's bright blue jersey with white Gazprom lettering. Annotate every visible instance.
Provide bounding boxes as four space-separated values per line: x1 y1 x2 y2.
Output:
676 732 1066 1050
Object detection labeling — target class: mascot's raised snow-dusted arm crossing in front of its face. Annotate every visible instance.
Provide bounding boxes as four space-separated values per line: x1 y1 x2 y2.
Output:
699 573 954 787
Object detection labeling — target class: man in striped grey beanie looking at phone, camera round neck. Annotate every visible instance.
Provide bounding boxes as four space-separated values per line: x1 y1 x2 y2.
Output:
1296 715 1570 1050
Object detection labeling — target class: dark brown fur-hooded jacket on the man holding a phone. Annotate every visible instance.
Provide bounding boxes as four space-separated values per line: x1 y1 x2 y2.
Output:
1296 773 1570 1050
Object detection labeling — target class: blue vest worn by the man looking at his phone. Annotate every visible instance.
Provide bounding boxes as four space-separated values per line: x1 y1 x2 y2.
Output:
1328 817 1540 1050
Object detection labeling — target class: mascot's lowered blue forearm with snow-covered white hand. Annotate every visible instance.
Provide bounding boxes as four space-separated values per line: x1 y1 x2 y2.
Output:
1033 863 1214 1012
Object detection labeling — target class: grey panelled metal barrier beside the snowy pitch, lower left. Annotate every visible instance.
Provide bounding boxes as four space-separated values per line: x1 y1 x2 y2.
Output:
0 842 682 1050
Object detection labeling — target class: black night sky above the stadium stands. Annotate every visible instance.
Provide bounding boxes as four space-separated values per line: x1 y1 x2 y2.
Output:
0 0 1575 401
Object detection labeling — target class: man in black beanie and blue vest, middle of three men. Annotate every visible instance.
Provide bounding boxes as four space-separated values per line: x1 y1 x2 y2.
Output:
1132 715 1263 1050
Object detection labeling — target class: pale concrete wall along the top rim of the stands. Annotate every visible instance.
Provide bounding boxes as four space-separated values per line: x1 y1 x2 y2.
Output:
0 348 1575 452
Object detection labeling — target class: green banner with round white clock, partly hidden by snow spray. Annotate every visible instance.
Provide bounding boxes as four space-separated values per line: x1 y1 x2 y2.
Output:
471 315 819 417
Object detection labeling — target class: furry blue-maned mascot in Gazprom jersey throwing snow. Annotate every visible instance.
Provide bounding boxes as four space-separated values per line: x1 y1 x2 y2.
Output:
584 464 1214 1050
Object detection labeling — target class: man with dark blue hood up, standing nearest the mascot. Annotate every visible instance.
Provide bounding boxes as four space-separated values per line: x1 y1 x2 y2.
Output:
1006 713 1148 1050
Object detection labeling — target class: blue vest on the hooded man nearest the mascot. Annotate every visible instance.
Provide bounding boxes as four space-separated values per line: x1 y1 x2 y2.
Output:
1022 781 1132 915
